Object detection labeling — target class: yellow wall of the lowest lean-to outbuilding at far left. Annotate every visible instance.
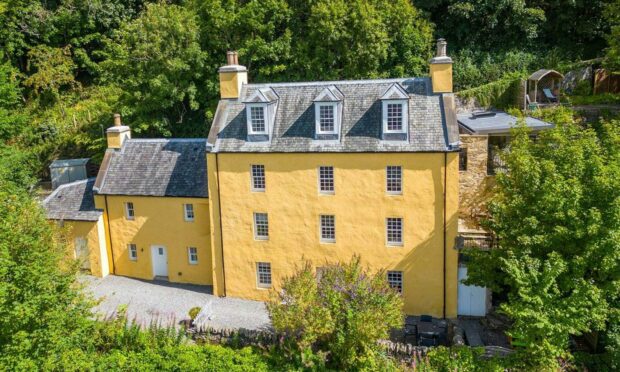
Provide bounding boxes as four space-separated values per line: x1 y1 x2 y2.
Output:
64 220 108 277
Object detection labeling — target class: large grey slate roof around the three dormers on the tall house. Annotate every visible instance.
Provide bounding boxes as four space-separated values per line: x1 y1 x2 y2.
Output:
208 78 458 152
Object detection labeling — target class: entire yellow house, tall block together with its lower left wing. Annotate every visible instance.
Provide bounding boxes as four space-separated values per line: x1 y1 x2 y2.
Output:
46 40 459 317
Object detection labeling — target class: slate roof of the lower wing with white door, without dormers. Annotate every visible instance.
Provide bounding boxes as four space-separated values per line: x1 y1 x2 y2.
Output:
94 138 208 198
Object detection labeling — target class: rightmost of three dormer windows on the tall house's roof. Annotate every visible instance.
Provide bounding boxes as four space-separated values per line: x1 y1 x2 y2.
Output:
381 83 409 141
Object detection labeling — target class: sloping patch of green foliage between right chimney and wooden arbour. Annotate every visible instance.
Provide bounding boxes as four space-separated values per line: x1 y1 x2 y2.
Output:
458 73 525 109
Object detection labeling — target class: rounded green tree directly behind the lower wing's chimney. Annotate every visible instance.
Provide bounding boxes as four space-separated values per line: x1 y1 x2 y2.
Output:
101 3 208 136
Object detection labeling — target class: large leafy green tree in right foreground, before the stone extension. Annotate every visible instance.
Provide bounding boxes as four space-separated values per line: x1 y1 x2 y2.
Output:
468 109 620 365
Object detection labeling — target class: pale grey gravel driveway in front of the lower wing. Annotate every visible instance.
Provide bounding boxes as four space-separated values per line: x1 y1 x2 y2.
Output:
83 275 270 329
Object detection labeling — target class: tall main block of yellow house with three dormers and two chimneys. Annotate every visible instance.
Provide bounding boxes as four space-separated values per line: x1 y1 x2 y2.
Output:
207 41 458 317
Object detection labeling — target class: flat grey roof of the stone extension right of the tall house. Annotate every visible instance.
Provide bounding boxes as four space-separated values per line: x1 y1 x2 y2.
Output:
457 111 553 134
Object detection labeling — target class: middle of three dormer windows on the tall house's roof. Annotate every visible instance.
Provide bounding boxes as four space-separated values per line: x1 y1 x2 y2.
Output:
314 85 344 140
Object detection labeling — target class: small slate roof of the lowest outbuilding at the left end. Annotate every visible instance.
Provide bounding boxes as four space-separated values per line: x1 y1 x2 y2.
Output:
43 178 102 221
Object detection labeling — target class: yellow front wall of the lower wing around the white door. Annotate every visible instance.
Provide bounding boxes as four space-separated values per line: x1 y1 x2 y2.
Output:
96 195 212 285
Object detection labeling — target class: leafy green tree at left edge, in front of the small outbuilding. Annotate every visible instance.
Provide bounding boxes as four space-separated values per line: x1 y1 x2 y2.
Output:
0 159 91 370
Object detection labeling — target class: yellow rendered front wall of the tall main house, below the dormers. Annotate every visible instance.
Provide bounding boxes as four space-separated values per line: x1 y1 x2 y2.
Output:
209 153 458 317
